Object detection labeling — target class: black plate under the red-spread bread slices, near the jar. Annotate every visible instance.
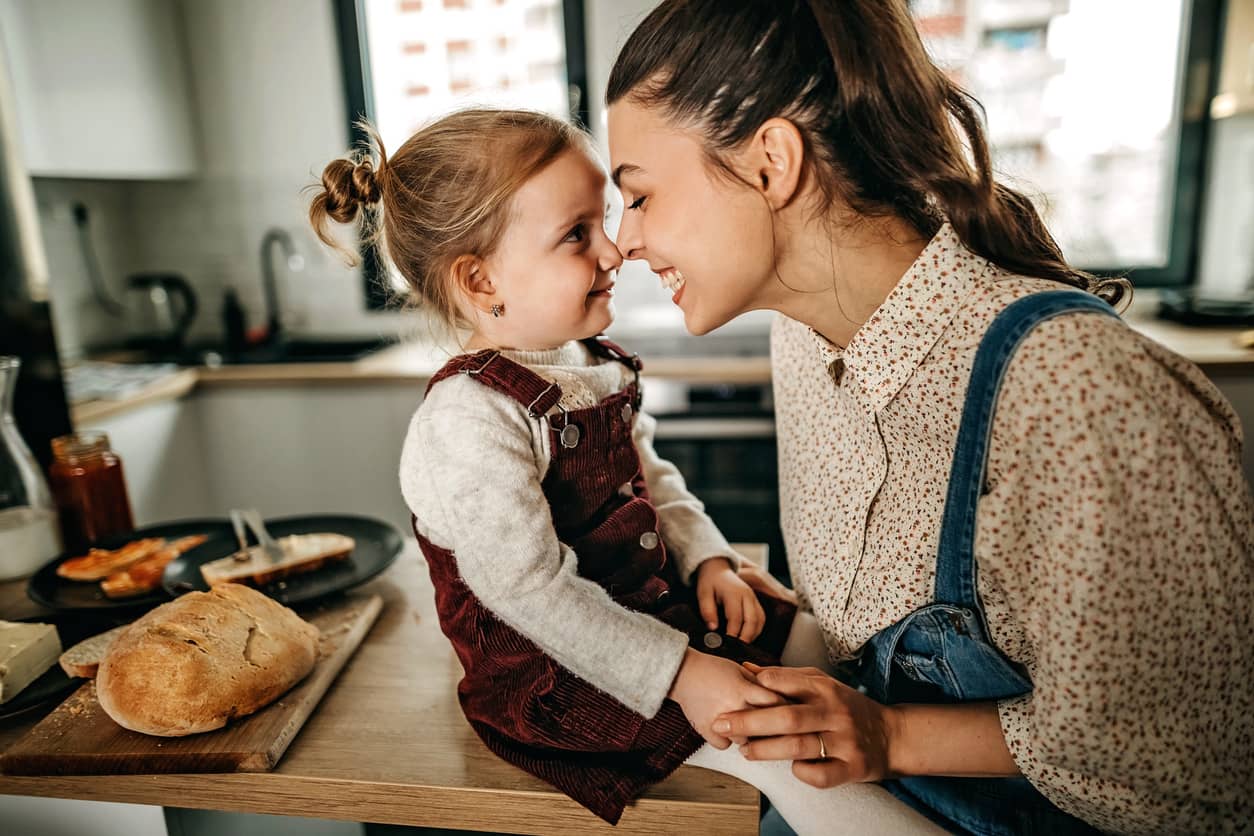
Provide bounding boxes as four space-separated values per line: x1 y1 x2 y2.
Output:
26 518 233 612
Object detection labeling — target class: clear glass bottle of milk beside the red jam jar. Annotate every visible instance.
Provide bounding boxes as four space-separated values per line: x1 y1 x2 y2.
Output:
0 356 61 580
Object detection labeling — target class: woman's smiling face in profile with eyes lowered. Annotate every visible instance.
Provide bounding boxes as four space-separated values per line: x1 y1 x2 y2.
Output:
608 99 775 335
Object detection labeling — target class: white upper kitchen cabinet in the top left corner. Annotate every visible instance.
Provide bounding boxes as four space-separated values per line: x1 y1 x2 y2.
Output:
0 0 198 179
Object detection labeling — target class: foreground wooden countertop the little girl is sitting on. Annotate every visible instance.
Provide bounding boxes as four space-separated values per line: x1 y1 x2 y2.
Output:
0 544 764 836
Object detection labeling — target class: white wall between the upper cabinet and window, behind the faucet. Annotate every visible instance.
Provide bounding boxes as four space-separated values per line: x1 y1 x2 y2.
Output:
134 0 408 343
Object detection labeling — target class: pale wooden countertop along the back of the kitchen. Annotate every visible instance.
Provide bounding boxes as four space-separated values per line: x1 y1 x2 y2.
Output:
70 291 1254 427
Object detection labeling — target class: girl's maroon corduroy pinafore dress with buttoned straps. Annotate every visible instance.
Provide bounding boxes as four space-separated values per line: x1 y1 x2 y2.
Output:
415 338 794 823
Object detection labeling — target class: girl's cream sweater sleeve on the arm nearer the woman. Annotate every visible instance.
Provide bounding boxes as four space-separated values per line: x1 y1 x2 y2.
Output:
632 412 741 583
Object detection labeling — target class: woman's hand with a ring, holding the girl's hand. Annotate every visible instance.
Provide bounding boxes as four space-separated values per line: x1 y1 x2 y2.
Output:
711 663 898 788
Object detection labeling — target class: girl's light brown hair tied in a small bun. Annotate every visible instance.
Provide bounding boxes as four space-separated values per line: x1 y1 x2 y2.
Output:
310 109 594 328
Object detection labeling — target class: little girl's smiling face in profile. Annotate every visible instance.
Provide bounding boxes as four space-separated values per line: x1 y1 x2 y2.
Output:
480 150 622 348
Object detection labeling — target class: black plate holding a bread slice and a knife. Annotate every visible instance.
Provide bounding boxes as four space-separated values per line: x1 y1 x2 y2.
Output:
162 514 403 604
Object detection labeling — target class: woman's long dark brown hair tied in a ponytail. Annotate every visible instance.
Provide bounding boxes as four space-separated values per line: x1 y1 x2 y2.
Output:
606 0 1130 305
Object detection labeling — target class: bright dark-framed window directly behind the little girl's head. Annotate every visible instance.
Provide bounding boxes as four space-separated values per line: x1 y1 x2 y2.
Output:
335 0 587 308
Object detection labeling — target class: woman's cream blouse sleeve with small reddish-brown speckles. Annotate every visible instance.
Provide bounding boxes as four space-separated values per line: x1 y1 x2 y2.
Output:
977 315 1254 833
